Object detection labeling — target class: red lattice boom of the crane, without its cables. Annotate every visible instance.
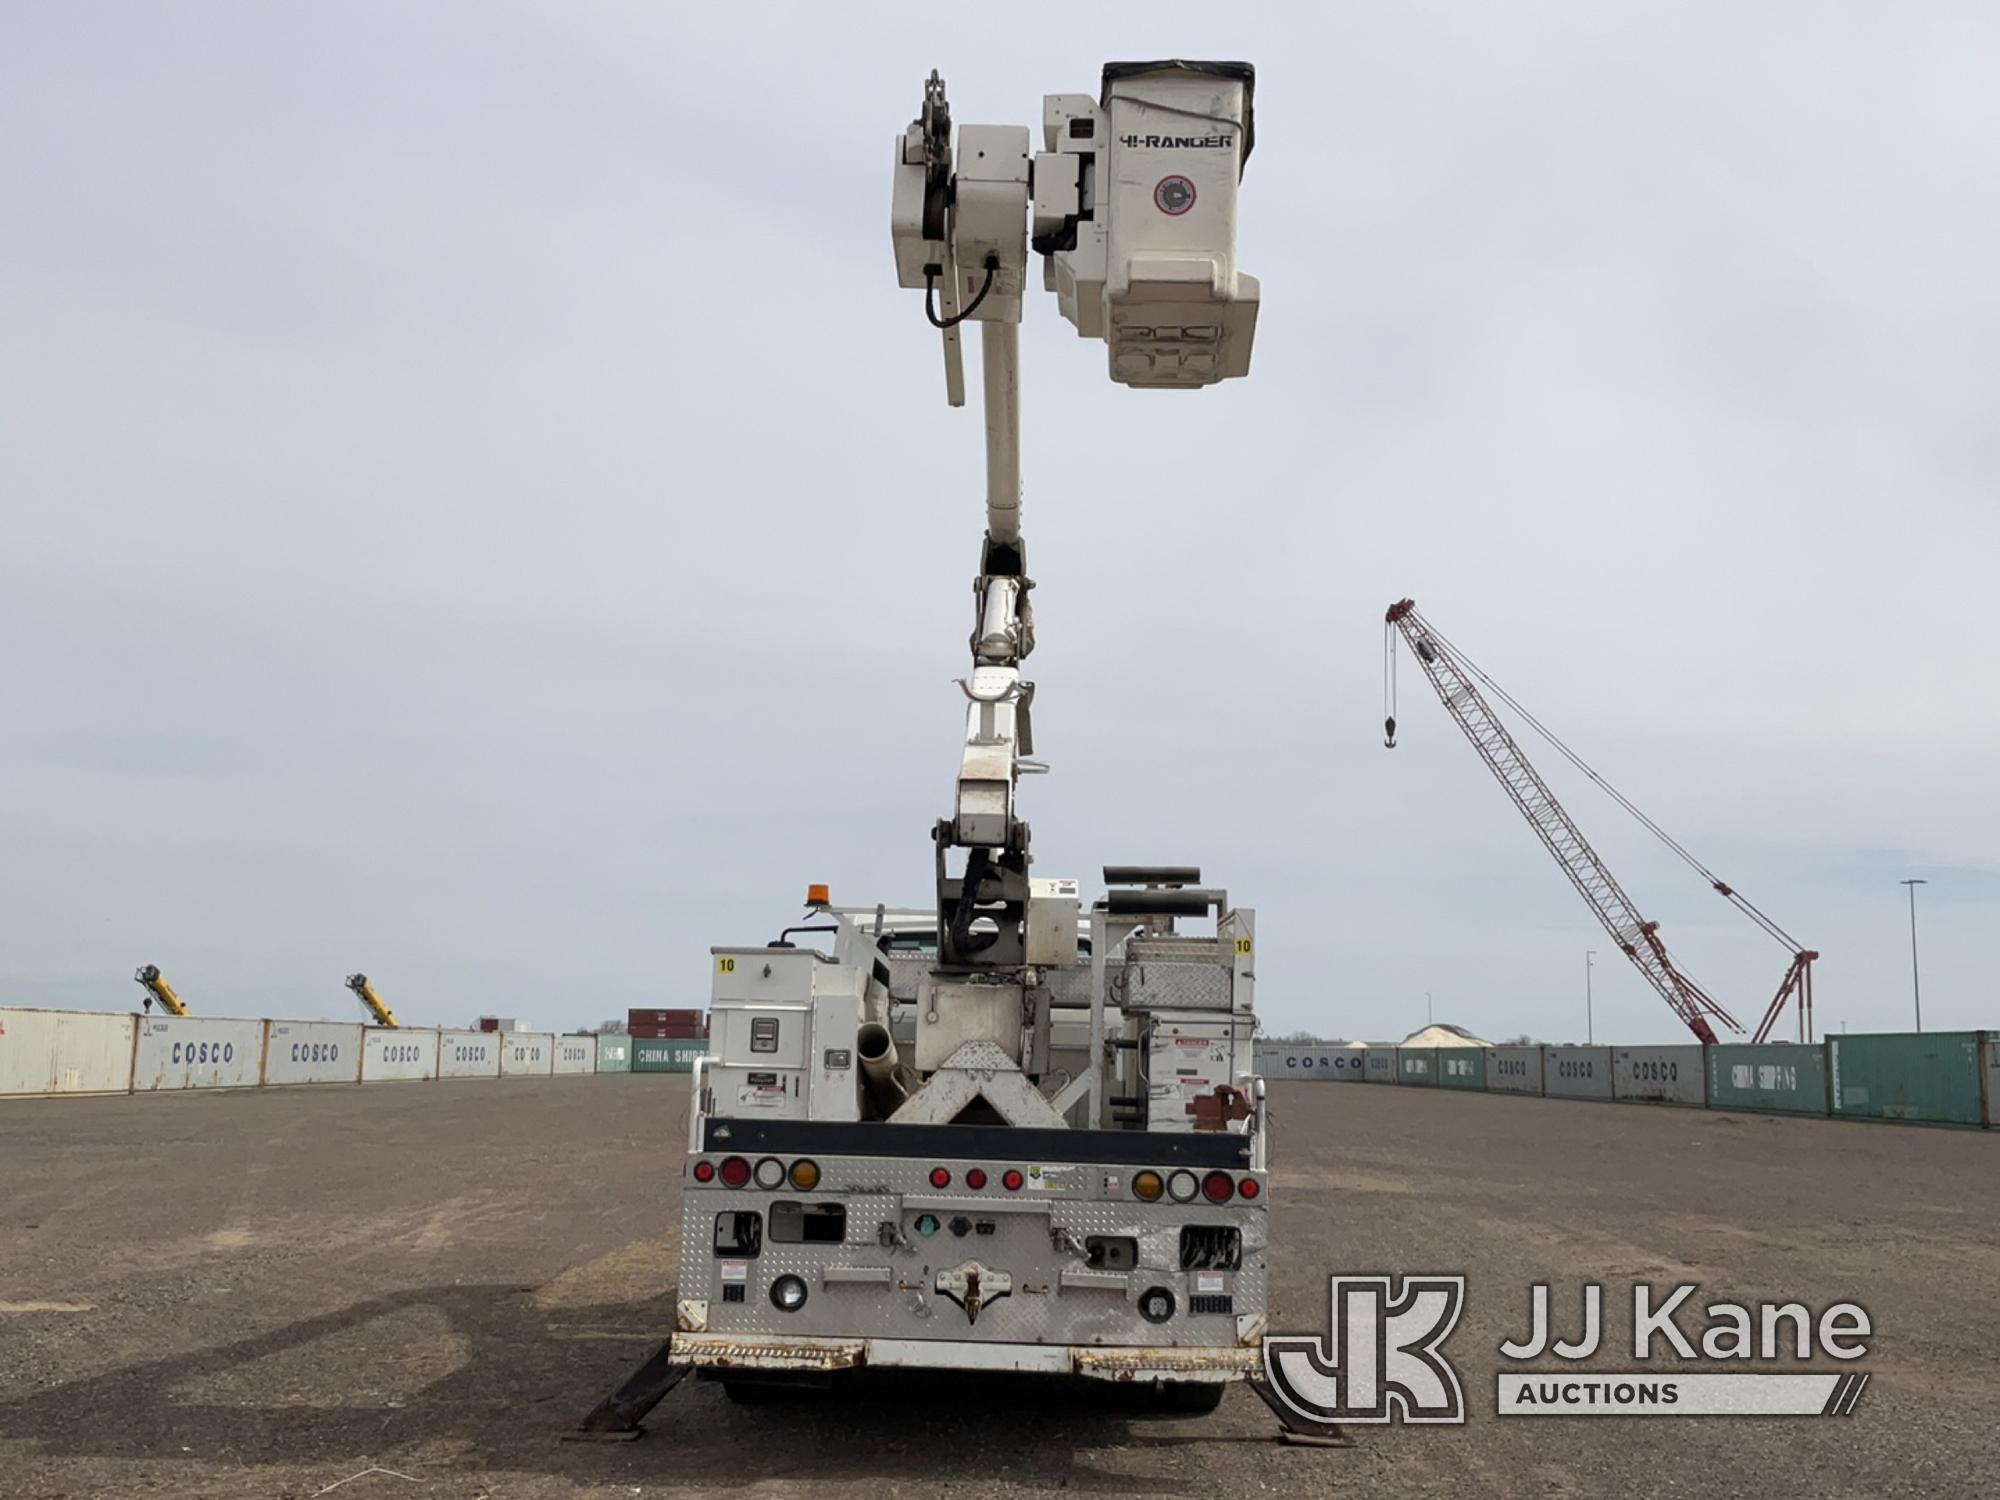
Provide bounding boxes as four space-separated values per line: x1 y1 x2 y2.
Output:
1388 600 1744 1046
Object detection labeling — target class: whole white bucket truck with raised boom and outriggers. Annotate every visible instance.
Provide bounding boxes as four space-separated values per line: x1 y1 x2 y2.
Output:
584 60 1300 1434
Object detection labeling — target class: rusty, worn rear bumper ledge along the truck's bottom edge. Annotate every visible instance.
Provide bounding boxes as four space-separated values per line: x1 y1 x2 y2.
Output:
668 1334 1262 1382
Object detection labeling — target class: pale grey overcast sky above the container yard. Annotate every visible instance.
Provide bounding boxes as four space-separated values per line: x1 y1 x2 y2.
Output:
0 2 2000 1042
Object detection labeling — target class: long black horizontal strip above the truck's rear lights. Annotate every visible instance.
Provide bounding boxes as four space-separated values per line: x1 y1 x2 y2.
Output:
702 1118 1250 1172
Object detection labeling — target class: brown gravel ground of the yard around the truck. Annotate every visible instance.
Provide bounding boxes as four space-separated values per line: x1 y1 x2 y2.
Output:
0 1076 2000 1500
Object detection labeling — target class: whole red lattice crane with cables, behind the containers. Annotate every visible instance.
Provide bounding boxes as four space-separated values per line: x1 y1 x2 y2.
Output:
1384 600 1818 1046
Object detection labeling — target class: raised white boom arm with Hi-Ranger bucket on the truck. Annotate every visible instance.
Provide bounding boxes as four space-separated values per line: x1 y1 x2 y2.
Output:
890 60 1258 968
